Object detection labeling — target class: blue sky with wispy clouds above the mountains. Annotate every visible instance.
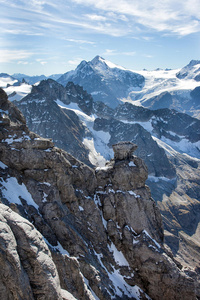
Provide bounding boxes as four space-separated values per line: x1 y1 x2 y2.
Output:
0 0 200 75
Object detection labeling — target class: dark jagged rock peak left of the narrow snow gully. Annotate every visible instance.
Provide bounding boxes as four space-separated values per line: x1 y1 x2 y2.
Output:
16 79 91 165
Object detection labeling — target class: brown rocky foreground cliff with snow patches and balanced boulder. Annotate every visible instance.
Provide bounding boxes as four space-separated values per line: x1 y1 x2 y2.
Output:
0 90 199 300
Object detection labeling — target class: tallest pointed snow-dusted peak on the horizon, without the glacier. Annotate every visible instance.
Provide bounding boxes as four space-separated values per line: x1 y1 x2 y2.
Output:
58 56 145 108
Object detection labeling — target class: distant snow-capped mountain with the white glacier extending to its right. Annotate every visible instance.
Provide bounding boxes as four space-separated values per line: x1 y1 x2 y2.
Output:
58 56 200 117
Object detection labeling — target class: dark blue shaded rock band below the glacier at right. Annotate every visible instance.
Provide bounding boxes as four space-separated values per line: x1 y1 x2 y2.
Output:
112 102 200 143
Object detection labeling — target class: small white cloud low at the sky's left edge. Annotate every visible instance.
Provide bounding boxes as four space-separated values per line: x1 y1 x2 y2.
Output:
0 49 33 63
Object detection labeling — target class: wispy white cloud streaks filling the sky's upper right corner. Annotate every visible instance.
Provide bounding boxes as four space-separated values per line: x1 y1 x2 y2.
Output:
74 0 200 36
